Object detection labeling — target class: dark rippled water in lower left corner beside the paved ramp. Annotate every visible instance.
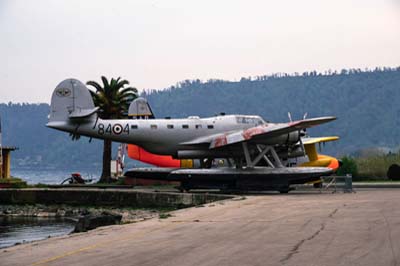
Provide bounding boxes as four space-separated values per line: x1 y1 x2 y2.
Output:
0 217 74 248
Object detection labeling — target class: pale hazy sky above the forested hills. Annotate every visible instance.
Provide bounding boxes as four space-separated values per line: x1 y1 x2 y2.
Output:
0 0 400 102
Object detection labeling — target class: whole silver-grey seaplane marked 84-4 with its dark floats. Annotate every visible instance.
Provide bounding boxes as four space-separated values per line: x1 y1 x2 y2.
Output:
46 79 336 193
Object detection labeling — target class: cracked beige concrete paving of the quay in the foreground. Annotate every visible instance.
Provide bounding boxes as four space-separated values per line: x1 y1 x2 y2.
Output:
0 189 400 266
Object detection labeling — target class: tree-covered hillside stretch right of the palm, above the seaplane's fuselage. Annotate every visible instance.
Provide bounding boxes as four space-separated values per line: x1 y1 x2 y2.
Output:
146 68 400 155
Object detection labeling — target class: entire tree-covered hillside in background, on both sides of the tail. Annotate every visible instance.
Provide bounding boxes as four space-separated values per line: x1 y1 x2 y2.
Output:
0 68 400 167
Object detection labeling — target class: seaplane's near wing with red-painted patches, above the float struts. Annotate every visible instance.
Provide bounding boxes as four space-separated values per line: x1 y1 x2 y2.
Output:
208 116 336 149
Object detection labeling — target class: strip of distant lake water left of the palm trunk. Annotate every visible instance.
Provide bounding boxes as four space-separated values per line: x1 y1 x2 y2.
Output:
11 169 101 184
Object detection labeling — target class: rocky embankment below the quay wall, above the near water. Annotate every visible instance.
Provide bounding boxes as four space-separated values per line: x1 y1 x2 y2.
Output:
0 204 160 232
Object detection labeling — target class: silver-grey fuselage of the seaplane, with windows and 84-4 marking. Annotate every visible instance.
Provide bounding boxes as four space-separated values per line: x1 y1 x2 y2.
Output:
47 115 298 157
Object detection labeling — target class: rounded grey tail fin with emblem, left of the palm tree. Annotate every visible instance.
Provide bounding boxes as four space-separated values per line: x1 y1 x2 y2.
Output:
49 79 98 122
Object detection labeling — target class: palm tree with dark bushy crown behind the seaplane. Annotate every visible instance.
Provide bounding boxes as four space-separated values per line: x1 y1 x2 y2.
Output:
86 76 137 183
